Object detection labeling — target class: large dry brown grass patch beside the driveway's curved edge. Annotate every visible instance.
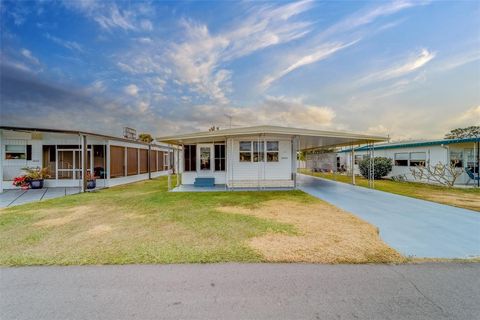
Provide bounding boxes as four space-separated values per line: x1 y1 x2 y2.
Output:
218 200 405 263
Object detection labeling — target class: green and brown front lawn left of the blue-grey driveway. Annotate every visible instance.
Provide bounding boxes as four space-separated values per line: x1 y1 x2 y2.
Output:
0 178 405 265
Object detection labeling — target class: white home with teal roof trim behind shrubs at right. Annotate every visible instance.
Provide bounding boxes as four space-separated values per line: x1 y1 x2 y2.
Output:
336 138 480 185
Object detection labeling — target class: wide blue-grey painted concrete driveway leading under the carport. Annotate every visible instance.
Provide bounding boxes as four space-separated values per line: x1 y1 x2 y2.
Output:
298 174 480 258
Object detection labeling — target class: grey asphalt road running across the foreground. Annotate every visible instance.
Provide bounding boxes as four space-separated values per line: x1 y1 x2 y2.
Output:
0 263 480 320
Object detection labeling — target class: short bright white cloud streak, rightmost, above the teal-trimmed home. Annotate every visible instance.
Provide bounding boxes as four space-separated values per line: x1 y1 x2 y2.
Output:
358 49 435 84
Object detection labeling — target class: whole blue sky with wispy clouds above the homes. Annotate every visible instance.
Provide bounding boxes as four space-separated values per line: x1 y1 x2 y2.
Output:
0 0 480 140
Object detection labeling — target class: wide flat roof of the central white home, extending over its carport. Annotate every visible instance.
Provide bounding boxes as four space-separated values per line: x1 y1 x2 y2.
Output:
157 125 388 150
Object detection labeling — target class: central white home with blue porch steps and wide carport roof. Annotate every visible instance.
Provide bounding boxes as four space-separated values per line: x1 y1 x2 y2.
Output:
157 126 387 189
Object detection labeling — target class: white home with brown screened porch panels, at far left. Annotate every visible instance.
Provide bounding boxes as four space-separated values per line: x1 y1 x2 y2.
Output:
0 126 174 192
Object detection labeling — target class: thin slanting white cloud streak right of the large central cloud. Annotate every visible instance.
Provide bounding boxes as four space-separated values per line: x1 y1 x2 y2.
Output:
261 41 357 89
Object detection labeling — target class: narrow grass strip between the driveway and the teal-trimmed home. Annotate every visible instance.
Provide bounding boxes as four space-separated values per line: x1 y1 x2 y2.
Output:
299 169 480 211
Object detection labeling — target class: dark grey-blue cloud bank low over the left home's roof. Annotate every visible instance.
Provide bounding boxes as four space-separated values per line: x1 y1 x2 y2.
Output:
0 63 180 136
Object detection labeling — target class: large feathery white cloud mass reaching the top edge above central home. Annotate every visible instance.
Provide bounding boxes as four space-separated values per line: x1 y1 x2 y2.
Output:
118 1 313 104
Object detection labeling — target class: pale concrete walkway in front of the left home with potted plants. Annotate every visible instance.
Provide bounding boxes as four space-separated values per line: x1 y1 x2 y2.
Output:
0 187 80 208
